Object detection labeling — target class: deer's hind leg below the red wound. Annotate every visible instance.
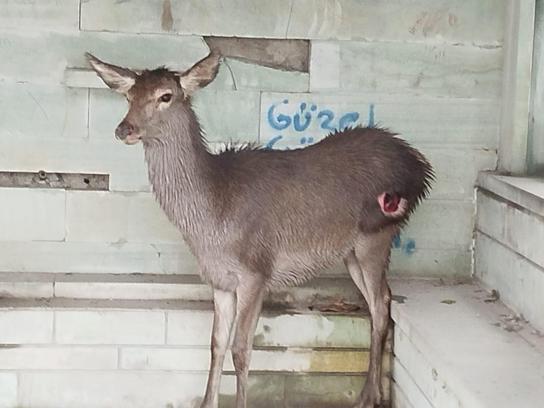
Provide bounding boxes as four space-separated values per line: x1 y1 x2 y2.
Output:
344 228 397 408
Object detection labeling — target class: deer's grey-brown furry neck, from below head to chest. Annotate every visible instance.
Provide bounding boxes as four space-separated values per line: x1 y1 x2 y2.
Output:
144 107 218 239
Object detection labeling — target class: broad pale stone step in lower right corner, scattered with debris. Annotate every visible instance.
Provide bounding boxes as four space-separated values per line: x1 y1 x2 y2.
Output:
392 281 544 408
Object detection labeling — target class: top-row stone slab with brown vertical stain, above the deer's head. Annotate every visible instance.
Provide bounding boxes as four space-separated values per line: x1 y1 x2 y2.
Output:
81 0 291 38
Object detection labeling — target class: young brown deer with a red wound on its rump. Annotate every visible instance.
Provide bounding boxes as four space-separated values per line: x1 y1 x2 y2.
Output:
87 54 433 408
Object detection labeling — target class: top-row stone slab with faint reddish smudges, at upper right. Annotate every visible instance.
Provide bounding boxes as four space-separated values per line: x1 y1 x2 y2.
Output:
287 0 506 45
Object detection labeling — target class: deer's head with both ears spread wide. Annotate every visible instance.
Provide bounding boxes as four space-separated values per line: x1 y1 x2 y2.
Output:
86 53 219 144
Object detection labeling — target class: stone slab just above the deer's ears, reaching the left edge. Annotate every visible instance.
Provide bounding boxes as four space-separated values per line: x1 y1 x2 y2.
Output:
0 30 209 84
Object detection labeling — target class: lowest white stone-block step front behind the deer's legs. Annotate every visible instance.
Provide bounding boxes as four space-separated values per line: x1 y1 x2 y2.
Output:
0 298 384 408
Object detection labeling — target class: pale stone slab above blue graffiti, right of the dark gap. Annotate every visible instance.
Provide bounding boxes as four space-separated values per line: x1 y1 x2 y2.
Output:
311 41 503 99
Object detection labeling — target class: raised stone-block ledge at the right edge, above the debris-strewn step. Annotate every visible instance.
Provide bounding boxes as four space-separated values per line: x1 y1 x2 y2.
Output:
474 173 544 332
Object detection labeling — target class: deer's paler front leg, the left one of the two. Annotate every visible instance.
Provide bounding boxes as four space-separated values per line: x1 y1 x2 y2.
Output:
200 289 236 408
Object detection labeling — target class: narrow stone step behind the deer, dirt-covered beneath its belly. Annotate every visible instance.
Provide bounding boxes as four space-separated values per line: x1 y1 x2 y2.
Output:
0 272 365 311
